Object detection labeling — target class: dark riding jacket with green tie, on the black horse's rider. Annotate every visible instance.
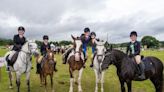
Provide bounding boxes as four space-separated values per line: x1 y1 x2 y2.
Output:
126 41 141 56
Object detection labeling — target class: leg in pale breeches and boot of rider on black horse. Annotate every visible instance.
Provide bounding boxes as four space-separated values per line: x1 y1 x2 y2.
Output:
135 55 145 79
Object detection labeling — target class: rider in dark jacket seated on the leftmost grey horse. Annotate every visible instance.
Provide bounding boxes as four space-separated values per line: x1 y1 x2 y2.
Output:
7 26 26 66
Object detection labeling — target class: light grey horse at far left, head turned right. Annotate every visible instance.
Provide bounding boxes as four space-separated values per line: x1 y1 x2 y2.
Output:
5 41 38 92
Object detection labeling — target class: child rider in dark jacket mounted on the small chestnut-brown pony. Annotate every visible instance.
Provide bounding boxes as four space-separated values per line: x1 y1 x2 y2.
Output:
37 35 57 73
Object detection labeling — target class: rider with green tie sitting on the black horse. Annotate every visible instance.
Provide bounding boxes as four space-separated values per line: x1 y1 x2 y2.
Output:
127 31 145 79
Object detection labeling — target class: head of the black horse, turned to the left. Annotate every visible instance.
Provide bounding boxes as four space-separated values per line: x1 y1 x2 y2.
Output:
101 46 116 70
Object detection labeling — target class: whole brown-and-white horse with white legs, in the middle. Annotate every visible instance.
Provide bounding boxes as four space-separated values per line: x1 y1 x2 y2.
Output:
67 35 85 92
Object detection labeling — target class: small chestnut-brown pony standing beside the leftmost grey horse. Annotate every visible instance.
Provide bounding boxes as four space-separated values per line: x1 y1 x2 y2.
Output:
40 49 55 92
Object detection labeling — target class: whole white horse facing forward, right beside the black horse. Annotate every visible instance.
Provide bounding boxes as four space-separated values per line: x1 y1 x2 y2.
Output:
93 41 106 92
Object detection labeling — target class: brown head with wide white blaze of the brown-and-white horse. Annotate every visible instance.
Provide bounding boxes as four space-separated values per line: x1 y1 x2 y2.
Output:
71 35 82 61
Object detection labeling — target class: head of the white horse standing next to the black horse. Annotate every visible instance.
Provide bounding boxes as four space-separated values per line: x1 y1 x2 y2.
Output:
95 40 106 61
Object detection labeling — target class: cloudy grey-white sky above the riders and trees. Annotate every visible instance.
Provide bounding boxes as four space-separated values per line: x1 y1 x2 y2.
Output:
0 0 164 43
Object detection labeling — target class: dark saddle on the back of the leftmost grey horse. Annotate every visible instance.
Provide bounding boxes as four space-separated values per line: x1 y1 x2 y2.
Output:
6 51 19 66
